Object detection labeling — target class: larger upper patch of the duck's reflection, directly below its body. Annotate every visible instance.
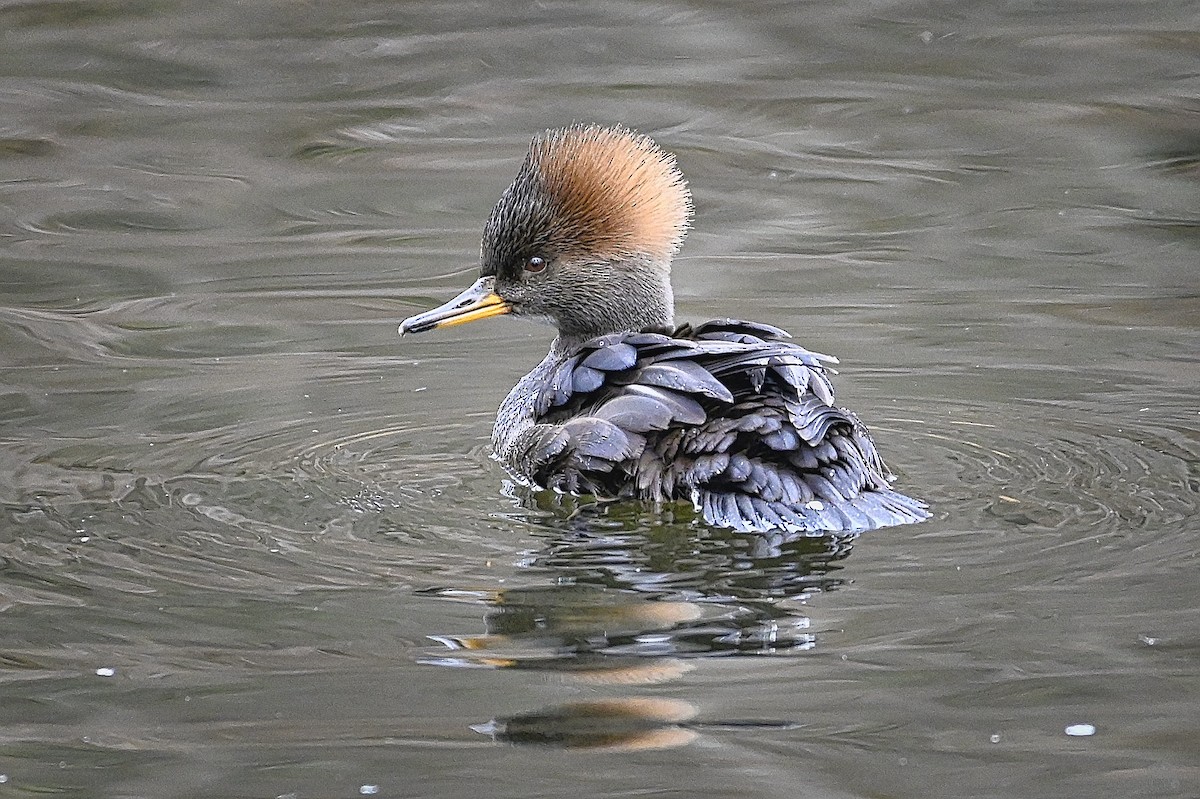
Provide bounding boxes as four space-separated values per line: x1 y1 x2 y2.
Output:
425 503 851 685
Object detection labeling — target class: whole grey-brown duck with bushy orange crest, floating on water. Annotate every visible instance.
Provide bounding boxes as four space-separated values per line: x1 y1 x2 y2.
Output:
400 124 930 536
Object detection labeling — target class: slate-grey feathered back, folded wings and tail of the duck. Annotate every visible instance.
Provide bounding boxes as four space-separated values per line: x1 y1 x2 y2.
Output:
533 319 929 533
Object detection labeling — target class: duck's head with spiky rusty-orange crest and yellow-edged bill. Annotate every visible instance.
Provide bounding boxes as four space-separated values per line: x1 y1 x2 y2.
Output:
400 125 691 341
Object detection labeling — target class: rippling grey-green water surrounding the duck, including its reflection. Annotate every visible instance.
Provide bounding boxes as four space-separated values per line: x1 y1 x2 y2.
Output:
0 0 1200 797
